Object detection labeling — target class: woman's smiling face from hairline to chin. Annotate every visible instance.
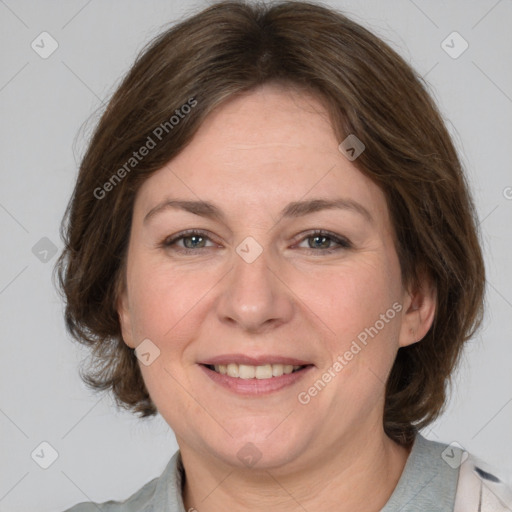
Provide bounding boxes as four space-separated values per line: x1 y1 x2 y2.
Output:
119 85 432 468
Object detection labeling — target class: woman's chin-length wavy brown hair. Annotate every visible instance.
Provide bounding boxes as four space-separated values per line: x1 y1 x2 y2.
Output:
56 1 484 444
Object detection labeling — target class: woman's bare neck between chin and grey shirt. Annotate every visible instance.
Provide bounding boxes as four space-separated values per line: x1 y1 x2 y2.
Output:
180 430 410 512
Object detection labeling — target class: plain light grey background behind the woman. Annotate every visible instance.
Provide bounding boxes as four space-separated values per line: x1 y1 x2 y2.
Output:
0 0 512 512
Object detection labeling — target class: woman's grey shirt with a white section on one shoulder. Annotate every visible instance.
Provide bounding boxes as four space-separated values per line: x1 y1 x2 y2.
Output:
65 434 512 512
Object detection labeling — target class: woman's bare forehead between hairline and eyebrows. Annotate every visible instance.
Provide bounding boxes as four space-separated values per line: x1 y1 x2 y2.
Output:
136 85 387 224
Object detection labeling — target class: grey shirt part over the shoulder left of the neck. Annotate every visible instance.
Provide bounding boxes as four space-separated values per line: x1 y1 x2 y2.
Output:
60 450 183 512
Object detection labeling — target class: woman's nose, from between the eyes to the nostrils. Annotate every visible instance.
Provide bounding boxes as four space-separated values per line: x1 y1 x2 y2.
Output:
217 242 295 333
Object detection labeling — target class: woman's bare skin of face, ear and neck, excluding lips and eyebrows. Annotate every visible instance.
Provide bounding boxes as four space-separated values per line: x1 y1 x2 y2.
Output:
118 84 435 512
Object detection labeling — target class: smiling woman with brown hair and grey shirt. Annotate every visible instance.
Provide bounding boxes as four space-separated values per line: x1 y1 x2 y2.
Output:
58 2 510 512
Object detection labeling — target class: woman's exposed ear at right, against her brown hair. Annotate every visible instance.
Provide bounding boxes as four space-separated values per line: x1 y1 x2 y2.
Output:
399 273 437 347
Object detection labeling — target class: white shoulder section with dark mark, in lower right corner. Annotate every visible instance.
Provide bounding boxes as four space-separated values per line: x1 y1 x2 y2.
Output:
453 454 512 512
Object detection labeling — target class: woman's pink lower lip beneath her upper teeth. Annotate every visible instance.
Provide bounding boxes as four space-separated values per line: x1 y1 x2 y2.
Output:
199 364 313 395
